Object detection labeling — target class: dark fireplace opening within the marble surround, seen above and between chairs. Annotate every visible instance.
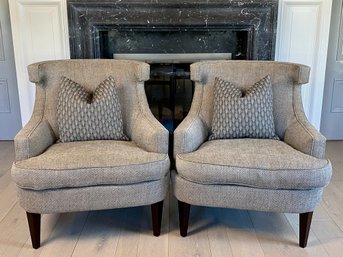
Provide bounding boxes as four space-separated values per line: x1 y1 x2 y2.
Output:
96 26 247 133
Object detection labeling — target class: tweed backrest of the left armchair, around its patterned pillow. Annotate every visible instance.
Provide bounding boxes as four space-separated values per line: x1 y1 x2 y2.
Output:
28 59 150 138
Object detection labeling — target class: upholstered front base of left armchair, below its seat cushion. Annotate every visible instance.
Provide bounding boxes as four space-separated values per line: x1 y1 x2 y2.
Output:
17 175 170 213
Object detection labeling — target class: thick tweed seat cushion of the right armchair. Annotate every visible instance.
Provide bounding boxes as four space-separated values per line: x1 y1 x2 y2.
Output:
176 139 331 189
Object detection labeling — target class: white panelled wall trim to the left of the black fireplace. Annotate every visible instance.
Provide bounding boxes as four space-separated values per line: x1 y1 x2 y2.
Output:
9 0 70 126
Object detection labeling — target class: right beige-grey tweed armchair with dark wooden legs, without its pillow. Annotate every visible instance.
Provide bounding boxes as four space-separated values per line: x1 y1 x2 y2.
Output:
172 61 332 247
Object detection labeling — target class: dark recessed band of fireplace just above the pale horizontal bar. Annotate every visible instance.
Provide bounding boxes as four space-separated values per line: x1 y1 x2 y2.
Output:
95 25 253 60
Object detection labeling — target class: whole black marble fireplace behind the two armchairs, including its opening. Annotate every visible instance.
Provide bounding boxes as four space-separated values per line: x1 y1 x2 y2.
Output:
67 0 278 133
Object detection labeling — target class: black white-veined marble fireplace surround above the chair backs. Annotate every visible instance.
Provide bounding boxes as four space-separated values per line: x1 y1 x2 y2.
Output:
67 0 278 60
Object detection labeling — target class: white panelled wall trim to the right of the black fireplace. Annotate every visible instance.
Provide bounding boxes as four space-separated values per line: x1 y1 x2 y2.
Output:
275 0 332 129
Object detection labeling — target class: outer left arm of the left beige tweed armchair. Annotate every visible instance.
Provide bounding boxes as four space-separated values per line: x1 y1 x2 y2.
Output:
14 119 56 161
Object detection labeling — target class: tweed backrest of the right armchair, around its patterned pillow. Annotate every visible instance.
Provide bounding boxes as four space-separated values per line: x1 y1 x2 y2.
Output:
190 60 309 140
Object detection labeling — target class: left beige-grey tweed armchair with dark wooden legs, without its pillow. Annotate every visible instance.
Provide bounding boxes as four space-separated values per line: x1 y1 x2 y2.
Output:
12 60 170 248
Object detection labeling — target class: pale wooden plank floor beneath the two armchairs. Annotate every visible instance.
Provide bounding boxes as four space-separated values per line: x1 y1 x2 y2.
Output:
0 141 343 257
